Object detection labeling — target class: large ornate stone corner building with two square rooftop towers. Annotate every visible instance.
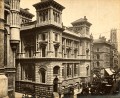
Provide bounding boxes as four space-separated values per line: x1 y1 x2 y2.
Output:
16 0 92 98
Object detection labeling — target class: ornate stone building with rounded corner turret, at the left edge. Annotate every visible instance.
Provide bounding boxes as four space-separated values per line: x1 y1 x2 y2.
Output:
0 0 33 98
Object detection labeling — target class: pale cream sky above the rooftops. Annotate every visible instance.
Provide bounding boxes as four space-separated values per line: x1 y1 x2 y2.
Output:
21 0 120 51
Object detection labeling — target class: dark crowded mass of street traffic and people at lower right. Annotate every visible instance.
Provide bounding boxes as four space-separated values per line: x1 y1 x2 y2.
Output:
81 77 119 95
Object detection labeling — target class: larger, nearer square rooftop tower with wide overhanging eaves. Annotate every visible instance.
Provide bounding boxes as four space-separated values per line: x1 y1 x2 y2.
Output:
33 0 64 27
